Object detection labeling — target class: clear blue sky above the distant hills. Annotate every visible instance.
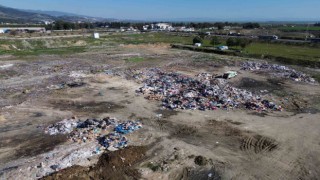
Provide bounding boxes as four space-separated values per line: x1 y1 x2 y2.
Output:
0 0 320 21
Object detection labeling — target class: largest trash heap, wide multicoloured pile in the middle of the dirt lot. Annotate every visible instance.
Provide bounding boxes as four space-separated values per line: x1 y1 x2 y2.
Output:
137 68 282 111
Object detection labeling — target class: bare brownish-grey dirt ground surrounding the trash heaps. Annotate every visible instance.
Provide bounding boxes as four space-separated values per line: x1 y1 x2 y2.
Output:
0 45 320 179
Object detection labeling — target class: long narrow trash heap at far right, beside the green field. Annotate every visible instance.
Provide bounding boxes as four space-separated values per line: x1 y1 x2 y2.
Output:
241 61 316 84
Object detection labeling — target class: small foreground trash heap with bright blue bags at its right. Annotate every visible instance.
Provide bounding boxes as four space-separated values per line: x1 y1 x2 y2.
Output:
45 117 142 151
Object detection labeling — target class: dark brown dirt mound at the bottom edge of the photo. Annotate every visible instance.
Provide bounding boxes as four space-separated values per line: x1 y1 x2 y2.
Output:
42 147 147 180
